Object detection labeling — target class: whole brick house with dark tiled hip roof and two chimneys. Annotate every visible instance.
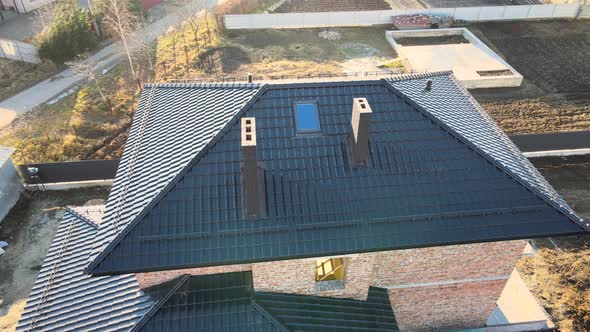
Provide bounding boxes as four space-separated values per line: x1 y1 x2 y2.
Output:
17 72 588 331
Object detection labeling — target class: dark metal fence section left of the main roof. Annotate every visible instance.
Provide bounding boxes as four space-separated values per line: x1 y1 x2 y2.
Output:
17 160 119 184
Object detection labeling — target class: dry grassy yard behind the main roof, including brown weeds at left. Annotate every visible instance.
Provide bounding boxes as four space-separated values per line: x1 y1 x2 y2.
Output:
157 22 400 80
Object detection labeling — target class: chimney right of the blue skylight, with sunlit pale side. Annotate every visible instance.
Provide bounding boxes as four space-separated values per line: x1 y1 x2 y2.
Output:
350 98 373 166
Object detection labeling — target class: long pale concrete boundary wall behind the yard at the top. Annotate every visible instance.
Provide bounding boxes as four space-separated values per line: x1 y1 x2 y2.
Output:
224 4 580 29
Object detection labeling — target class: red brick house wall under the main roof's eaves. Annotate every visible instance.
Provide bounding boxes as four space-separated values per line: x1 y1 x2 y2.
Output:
136 241 525 331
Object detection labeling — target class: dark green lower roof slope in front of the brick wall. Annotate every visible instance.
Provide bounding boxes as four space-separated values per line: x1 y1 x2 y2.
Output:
134 272 398 332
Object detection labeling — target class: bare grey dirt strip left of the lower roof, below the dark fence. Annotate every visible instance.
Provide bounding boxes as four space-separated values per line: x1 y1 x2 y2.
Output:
0 188 110 331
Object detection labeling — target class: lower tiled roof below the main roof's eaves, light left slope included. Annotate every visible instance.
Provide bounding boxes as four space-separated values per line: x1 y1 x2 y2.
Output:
16 210 397 332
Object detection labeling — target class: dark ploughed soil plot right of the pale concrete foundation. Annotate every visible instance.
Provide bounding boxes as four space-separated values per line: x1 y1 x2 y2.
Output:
469 20 590 134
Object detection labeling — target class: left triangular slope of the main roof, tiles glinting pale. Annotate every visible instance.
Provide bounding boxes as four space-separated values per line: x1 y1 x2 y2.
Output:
92 84 260 272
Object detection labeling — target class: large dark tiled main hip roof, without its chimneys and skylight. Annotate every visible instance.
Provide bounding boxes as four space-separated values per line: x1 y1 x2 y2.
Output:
87 73 587 275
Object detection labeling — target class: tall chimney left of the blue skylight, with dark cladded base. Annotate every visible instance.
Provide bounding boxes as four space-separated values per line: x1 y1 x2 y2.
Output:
241 118 266 217
